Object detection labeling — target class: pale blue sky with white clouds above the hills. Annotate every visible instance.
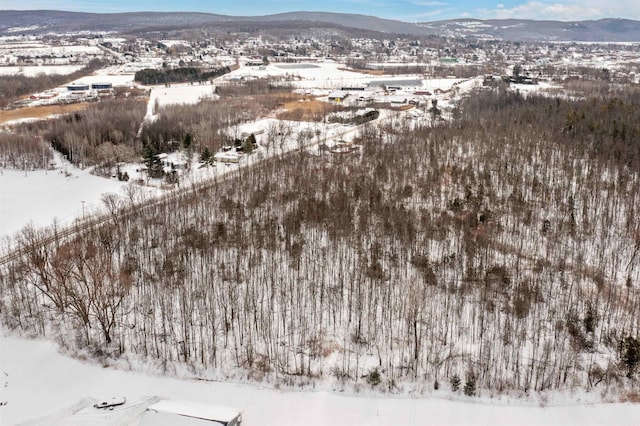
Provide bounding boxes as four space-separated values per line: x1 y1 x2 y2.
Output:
0 0 640 22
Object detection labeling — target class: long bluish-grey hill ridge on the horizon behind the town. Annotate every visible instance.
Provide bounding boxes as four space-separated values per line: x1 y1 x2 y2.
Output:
0 10 640 42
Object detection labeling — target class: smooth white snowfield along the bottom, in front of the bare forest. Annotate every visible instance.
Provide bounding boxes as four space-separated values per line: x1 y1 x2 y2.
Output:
0 336 640 426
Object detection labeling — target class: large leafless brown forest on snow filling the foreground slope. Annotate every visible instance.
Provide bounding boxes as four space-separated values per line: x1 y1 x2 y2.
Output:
0 85 640 395
